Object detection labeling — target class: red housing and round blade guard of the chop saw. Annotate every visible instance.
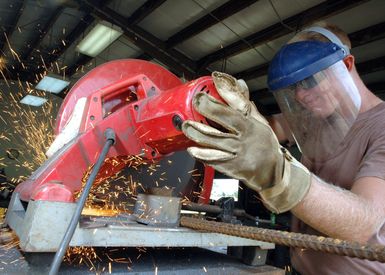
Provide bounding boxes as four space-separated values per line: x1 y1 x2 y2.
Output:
15 60 219 205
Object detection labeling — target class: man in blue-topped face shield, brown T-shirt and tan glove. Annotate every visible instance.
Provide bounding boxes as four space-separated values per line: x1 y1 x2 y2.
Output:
183 24 385 274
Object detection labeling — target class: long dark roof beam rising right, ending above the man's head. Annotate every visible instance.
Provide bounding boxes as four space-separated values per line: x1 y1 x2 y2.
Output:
198 0 368 68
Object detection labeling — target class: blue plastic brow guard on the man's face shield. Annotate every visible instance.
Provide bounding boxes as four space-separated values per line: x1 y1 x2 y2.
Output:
267 41 347 91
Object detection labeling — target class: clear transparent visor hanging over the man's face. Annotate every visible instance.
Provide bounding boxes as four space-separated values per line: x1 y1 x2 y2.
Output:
274 60 361 162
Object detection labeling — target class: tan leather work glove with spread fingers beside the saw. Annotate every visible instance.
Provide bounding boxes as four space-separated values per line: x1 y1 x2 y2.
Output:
182 72 311 213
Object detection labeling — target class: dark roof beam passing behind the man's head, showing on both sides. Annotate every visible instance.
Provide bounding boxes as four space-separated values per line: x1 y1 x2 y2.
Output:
234 22 385 80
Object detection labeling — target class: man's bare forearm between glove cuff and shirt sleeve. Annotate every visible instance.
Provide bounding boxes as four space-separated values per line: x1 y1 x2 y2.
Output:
292 176 384 242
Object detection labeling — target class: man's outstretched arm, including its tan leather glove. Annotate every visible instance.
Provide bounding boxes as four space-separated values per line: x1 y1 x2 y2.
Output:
182 73 385 242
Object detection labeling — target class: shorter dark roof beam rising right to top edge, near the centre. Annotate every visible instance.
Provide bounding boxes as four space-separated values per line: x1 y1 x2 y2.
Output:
166 0 258 48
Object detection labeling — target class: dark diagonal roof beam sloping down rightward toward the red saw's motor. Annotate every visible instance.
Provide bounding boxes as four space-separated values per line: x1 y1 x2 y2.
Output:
82 0 202 79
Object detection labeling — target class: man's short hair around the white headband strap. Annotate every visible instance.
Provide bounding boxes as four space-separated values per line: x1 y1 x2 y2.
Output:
287 21 352 49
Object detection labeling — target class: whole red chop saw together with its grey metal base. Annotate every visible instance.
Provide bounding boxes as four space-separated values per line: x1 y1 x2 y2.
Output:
6 59 270 254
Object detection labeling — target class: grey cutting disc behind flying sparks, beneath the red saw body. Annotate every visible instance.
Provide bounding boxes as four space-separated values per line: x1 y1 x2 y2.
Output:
88 151 205 211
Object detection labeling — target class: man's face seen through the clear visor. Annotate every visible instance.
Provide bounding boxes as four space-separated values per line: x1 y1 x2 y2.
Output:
295 75 338 118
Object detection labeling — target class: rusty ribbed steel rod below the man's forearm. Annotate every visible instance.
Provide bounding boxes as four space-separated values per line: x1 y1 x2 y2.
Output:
180 217 385 263
